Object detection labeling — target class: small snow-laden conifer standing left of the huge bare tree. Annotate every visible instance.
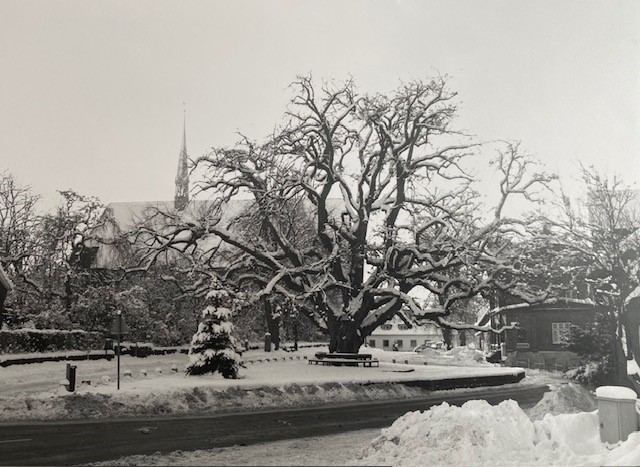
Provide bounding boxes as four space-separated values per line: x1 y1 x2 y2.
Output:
187 287 243 378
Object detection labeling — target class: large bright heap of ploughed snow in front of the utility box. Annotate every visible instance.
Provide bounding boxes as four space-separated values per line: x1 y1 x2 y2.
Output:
358 400 640 466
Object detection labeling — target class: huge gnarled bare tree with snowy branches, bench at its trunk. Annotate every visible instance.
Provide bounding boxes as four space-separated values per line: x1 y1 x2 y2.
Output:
132 77 550 352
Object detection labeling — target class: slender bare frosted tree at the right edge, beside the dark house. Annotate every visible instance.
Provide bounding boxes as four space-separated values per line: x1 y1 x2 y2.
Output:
544 167 640 390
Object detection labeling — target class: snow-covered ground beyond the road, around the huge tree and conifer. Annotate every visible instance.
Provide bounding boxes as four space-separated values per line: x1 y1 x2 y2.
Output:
0 347 550 421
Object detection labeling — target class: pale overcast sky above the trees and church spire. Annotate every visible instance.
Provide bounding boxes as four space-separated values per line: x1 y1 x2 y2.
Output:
0 0 640 209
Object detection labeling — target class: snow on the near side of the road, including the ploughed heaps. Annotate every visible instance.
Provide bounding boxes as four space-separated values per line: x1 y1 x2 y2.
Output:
94 384 640 466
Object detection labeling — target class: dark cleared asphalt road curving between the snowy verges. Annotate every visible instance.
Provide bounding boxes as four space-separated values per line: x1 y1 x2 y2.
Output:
0 386 548 465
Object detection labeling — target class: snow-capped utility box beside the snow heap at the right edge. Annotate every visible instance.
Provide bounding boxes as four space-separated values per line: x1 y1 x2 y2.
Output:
596 386 638 444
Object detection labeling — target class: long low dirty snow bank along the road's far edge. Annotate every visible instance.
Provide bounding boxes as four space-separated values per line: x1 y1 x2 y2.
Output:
0 383 436 421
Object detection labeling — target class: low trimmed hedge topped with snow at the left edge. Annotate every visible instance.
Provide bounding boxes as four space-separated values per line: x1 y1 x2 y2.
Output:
0 329 105 354
